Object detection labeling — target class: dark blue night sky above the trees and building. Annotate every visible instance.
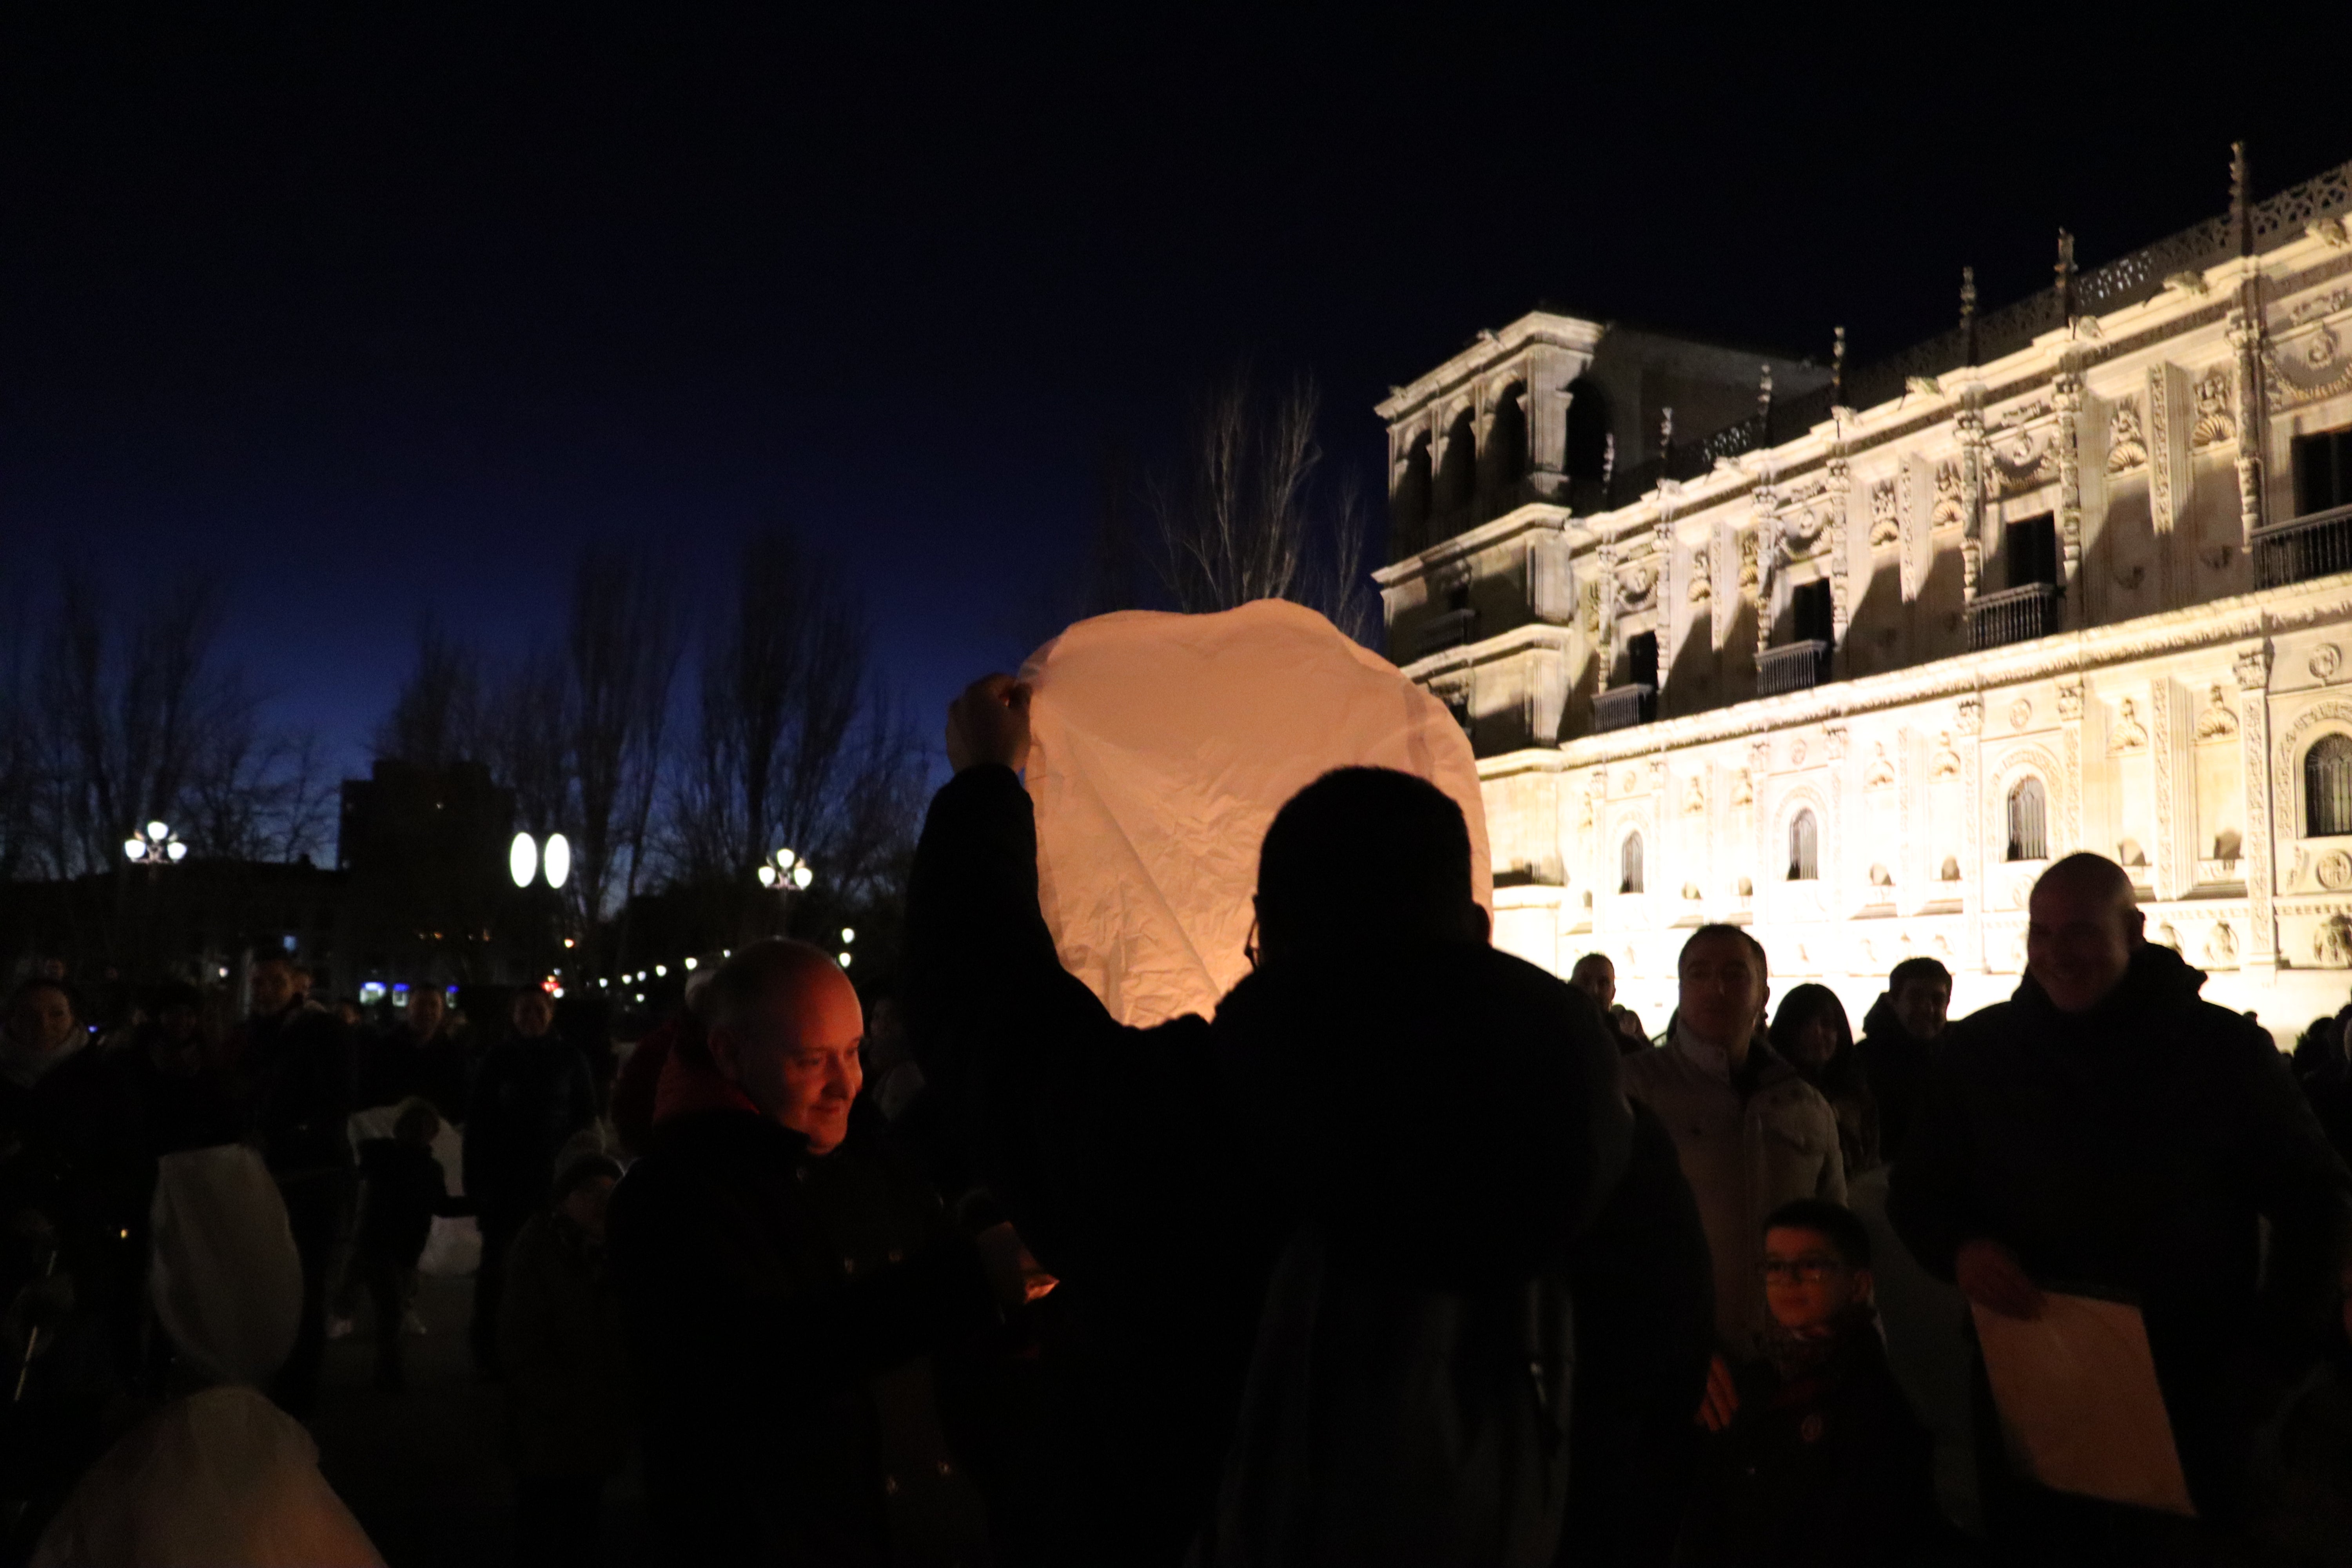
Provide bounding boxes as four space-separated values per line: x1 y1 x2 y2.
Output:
0 5 2352 766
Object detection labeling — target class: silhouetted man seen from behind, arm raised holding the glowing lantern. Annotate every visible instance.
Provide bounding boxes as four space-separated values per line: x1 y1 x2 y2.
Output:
908 677 1712 1566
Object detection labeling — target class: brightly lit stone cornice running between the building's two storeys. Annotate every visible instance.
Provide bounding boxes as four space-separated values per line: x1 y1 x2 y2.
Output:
1534 576 2352 776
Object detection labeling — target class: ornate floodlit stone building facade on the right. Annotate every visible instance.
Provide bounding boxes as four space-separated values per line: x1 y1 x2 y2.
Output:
1378 152 2352 1032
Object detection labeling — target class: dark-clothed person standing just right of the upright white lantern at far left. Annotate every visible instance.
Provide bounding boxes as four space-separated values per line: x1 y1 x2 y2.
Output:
230 959 358 1420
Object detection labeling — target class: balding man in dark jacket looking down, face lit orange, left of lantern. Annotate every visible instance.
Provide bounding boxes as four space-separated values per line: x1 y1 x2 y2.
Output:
609 940 997 1568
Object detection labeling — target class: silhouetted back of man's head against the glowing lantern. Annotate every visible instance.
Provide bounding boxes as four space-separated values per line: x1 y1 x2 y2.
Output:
1256 769 1486 962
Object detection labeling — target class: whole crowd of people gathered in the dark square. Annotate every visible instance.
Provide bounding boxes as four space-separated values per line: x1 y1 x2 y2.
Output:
0 677 2352 1568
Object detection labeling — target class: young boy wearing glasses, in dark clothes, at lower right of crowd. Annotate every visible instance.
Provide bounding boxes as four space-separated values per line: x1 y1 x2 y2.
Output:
1675 1199 1936 1568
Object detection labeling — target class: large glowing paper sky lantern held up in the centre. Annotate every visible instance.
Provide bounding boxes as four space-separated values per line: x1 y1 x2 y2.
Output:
1021 599 1494 1025
